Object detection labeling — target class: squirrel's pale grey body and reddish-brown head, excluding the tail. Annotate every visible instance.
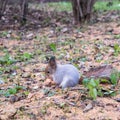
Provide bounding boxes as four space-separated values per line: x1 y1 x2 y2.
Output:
45 57 80 89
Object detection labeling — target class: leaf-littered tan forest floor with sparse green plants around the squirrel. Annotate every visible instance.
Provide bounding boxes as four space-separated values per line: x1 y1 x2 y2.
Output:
0 6 120 120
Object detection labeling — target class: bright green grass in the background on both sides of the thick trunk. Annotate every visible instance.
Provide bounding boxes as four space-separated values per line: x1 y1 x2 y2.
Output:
30 0 120 12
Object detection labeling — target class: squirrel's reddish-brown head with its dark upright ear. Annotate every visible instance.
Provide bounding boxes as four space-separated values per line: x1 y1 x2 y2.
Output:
45 57 57 79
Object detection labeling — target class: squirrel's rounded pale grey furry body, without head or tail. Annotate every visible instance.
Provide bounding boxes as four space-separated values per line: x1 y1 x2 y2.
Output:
52 64 80 88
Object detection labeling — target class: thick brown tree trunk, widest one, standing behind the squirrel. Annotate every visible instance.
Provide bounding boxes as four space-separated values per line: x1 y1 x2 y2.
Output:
71 0 96 24
